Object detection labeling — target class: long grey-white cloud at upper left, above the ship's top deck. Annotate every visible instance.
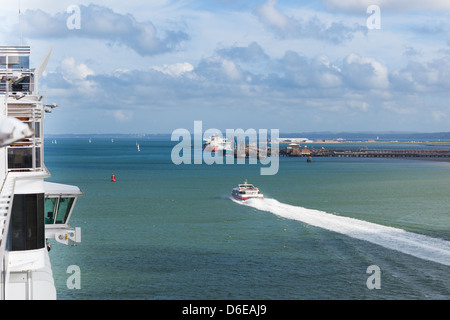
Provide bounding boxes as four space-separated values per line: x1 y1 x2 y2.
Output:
22 4 189 56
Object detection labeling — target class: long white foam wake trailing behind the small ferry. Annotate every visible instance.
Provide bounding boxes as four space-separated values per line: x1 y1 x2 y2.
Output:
232 199 450 266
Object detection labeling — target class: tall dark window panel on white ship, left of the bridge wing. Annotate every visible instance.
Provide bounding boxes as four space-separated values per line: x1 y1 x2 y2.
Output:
11 193 45 251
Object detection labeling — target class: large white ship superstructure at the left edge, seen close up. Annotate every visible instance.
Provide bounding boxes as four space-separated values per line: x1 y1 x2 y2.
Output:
0 46 83 300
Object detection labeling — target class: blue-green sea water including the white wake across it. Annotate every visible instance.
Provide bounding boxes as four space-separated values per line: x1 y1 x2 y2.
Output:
44 138 450 300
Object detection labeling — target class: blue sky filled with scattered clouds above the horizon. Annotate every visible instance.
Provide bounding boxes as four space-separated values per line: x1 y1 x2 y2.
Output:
0 0 450 134
